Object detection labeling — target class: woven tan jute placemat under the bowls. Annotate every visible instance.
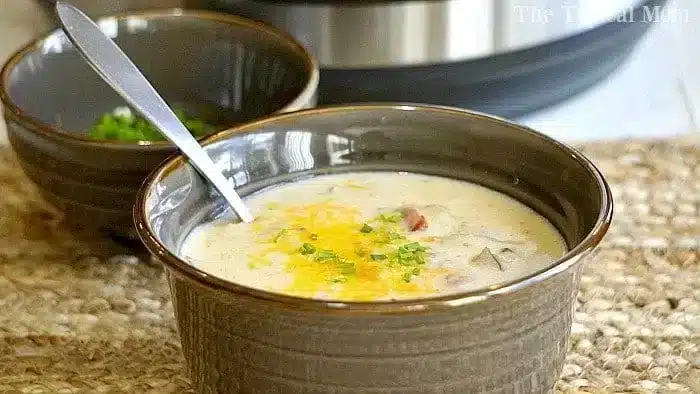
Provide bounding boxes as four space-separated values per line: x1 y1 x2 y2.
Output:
0 136 700 393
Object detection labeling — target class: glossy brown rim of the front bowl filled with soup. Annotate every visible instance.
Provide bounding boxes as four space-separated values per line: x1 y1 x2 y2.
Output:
134 103 613 314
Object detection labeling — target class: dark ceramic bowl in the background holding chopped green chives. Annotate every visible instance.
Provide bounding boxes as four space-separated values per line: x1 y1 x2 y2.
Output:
0 9 318 237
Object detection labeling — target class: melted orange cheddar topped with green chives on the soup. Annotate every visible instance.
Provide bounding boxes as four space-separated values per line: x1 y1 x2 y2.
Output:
248 200 439 300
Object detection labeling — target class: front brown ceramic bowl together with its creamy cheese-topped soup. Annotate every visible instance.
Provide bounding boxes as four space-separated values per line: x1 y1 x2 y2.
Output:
134 103 612 393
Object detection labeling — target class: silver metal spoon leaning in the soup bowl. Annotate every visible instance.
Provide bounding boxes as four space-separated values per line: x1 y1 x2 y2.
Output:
56 1 253 223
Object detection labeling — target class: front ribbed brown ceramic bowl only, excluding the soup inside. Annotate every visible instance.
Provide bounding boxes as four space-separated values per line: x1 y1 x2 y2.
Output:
134 104 612 394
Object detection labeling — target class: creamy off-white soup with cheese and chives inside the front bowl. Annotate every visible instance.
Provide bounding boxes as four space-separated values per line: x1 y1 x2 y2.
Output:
181 172 566 301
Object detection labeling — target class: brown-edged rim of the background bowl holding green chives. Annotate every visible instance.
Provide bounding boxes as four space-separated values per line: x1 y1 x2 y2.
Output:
0 8 320 150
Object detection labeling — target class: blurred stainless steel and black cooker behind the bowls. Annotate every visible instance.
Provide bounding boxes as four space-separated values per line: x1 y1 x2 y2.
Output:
199 0 666 117
